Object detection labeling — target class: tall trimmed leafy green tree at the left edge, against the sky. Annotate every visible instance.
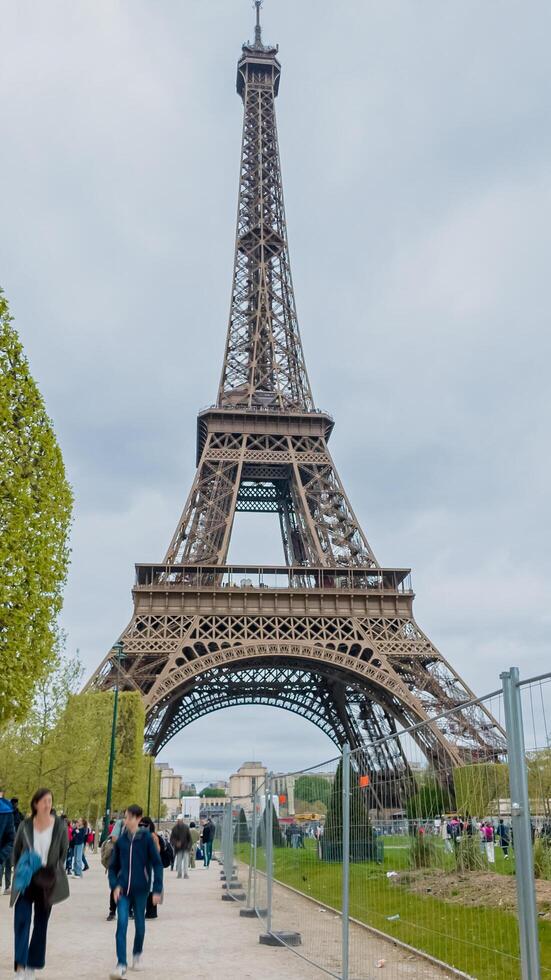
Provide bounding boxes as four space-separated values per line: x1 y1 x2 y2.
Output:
0 291 72 726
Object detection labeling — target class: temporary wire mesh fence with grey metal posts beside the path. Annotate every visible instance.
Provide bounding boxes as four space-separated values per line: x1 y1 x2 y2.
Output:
216 668 551 980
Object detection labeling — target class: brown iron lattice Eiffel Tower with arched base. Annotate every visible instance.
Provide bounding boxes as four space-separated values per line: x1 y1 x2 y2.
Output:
88 0 502 776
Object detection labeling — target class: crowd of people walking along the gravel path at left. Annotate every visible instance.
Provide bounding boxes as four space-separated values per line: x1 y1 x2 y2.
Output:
0 788 220 980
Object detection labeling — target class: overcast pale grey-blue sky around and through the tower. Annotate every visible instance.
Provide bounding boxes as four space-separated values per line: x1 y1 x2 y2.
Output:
0 0 551 779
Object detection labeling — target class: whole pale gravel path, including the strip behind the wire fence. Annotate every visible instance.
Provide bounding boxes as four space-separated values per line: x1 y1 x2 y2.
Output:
0 856 449 980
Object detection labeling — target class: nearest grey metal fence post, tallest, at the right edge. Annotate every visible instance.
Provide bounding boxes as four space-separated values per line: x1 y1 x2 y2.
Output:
500 667 541 980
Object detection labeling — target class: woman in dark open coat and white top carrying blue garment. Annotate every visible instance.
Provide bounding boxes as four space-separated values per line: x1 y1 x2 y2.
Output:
10 788 69 980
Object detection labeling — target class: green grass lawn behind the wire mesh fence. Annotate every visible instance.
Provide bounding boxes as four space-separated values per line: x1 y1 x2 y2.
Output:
236 837 551 980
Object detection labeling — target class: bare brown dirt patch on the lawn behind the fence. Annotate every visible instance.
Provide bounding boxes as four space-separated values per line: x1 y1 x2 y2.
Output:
391 870 551 922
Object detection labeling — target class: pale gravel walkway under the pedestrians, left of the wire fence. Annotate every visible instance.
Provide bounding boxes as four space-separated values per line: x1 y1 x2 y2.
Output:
0 856 323 980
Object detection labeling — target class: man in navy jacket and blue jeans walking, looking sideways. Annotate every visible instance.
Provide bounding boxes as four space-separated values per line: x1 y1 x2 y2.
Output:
109 803 163 980
